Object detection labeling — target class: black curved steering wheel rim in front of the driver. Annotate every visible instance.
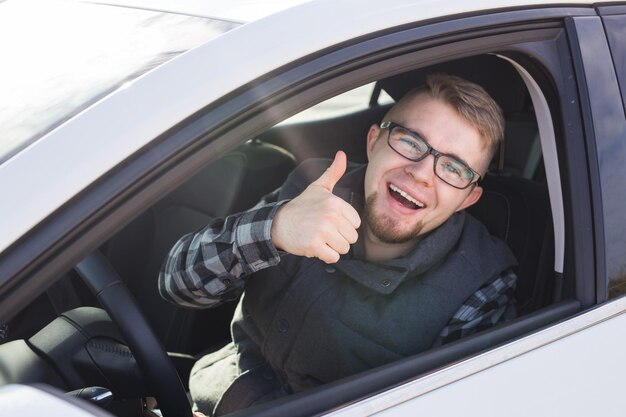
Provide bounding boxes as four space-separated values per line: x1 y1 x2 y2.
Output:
75 250 192 417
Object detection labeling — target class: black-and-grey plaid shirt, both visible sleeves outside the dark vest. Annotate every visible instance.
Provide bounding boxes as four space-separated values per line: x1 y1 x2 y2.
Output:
159 201 517 346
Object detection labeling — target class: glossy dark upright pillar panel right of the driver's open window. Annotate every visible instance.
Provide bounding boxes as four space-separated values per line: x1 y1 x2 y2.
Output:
566 16 626 304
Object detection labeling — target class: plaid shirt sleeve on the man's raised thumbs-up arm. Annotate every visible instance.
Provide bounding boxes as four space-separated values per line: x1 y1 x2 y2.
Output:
159 193 286 308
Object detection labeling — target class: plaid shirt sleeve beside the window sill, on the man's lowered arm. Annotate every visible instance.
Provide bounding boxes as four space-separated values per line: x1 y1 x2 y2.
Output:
434 268 517 346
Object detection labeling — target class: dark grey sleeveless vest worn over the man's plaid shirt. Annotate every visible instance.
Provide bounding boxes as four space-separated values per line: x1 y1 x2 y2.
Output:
190 160 515 415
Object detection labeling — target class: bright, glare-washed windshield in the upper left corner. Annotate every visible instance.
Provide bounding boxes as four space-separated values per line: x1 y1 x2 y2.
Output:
0 0 238 163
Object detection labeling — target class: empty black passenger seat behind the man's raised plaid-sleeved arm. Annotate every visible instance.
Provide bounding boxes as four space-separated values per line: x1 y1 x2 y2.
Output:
102 140 296 353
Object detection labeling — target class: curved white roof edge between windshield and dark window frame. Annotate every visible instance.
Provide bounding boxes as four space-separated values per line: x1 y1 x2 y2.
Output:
0 0 616 252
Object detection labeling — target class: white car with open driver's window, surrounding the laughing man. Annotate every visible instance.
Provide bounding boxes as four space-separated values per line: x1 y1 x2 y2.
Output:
0 0 626 417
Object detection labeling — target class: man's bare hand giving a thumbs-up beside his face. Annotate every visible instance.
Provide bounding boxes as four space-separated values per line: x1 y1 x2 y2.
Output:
271 151 361 263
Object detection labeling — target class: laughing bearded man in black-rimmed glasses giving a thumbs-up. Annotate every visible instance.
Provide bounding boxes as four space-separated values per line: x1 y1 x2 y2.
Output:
159 74 516 415
